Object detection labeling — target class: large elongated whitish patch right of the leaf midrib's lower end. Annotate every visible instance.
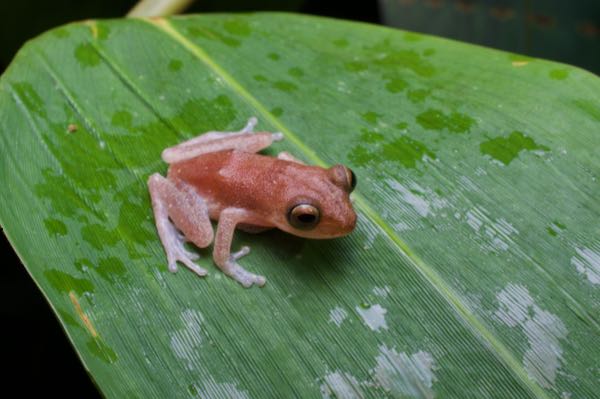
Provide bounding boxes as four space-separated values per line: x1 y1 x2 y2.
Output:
495 284 567 388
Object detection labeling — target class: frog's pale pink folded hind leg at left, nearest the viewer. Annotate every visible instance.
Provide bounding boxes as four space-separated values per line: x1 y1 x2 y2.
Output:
148 173 214 276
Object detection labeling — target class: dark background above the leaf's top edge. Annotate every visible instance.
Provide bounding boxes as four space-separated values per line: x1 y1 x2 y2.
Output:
0 0 600 74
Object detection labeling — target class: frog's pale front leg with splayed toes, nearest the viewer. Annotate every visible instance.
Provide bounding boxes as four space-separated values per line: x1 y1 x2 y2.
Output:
213 208 266 288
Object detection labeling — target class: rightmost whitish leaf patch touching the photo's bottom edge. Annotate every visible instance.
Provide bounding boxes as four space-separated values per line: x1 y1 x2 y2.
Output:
373 345 436 398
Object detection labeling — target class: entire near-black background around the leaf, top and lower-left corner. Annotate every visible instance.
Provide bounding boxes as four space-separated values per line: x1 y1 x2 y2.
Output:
0 0 600 398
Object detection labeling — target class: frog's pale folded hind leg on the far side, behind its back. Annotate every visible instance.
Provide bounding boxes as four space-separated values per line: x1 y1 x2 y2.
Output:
162 117 283 164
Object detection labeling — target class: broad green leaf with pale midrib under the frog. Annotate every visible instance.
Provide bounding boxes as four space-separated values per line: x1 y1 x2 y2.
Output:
0 14 600 398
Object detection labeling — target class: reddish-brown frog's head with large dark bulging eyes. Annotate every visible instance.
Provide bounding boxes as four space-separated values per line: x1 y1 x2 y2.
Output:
279 165 356 238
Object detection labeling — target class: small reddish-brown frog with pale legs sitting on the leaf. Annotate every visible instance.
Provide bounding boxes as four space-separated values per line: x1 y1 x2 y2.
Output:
148 117 357 287
